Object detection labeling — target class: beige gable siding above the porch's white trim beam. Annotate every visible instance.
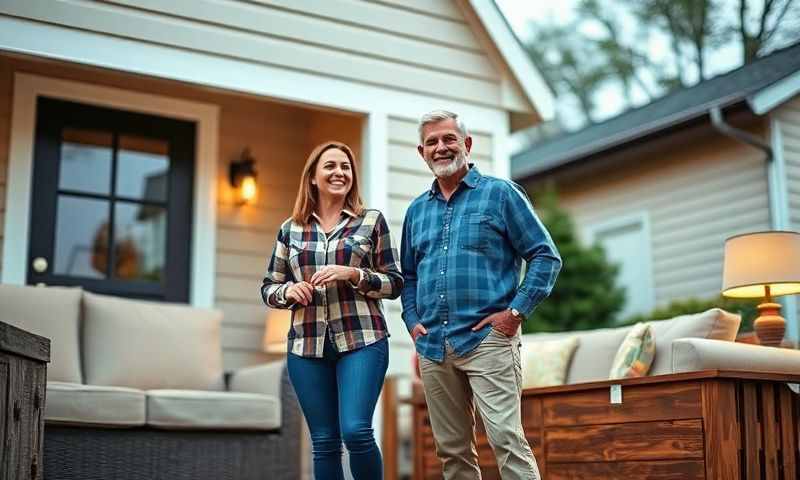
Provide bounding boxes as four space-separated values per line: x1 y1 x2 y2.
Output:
0 0 529 110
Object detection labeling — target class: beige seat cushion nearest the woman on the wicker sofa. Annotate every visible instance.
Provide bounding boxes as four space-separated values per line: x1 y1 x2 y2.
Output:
147 390 281 430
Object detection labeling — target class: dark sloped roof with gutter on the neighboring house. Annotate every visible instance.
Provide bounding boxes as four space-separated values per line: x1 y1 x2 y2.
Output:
511 39 800 180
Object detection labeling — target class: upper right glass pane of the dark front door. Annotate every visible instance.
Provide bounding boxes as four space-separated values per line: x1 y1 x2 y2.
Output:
117 135 169 202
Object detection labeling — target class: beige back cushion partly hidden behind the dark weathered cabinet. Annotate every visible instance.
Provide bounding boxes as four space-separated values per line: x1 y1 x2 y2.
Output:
0 284 83 383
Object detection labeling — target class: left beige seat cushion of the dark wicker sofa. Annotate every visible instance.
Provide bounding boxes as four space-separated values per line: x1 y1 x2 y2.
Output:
44 382 145 427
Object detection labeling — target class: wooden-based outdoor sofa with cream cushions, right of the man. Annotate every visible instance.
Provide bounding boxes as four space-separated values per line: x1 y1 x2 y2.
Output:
412 309 800 480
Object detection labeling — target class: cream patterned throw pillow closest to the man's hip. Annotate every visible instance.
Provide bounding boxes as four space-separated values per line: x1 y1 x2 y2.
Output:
520 337 578 388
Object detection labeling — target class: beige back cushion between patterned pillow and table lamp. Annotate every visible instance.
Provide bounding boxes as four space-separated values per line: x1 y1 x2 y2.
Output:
650 308 742 375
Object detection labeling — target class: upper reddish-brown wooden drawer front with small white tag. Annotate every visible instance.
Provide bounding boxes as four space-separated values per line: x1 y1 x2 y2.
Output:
542 382 702 427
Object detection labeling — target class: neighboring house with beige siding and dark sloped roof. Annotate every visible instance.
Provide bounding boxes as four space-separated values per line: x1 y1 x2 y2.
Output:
512 40 800 339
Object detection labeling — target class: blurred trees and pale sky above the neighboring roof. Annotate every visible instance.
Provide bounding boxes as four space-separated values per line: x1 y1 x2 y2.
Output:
526 0 800 128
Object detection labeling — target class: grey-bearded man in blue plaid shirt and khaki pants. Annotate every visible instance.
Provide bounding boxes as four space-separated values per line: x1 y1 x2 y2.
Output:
401 110 561 480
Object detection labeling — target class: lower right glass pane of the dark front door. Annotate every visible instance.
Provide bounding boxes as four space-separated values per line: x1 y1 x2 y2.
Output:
114 202 167 282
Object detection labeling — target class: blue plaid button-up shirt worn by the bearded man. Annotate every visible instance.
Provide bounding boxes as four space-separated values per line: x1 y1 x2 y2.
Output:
400 165 561 361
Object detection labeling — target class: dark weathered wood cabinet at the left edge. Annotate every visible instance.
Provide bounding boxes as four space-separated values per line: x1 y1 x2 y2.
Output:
0 322 50 480
